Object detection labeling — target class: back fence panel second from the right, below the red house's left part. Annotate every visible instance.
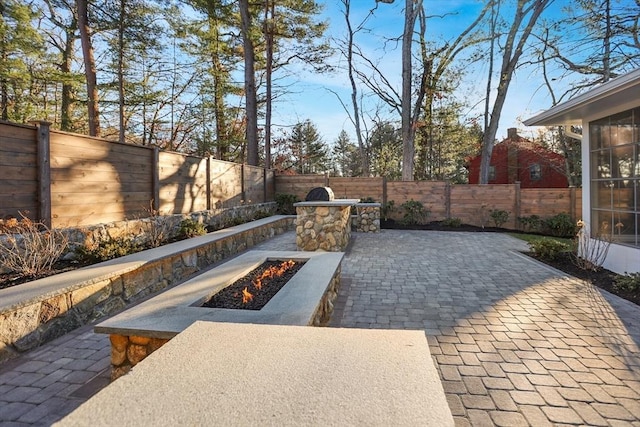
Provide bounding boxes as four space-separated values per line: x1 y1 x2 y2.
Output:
451 184 518 229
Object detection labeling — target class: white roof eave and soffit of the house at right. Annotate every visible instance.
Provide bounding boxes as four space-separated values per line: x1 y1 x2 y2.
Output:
524 69 640 126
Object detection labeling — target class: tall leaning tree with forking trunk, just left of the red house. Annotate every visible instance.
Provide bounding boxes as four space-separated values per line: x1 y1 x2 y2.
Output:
479 0 553 184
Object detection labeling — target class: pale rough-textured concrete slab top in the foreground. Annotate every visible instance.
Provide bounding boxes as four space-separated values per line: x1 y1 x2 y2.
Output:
56 322 454 427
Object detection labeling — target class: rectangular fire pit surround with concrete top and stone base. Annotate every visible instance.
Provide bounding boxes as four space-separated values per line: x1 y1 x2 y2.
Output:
95 251 344 379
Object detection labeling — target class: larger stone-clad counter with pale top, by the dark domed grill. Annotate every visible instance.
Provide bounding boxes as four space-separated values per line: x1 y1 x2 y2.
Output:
293 199 360 252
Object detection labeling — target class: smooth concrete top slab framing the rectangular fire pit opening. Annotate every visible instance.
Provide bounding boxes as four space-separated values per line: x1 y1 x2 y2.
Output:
94 250 344 339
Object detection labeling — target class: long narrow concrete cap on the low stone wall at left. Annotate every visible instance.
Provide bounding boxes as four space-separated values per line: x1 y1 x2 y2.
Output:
0 215 294 312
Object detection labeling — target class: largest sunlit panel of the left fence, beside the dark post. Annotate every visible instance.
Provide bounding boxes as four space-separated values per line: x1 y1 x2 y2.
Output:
50 131 153 227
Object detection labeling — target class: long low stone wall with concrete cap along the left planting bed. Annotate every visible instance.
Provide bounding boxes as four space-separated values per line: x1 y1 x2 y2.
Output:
0 216 294 362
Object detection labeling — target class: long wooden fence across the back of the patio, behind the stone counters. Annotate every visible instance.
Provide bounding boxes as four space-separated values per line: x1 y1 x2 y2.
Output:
275 175 582 229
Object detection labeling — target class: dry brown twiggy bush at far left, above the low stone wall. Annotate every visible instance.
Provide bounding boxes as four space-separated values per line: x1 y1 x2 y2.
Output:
0 214 69 277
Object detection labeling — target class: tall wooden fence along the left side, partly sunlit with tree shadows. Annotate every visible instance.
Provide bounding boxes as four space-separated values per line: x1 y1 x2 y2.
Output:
0 122 275 227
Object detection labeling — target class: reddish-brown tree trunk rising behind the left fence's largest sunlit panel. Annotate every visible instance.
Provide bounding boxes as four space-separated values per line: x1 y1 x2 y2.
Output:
76 0 100 136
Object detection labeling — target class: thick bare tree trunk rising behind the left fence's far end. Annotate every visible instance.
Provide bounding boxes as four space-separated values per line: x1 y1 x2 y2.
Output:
238 0 258 166
